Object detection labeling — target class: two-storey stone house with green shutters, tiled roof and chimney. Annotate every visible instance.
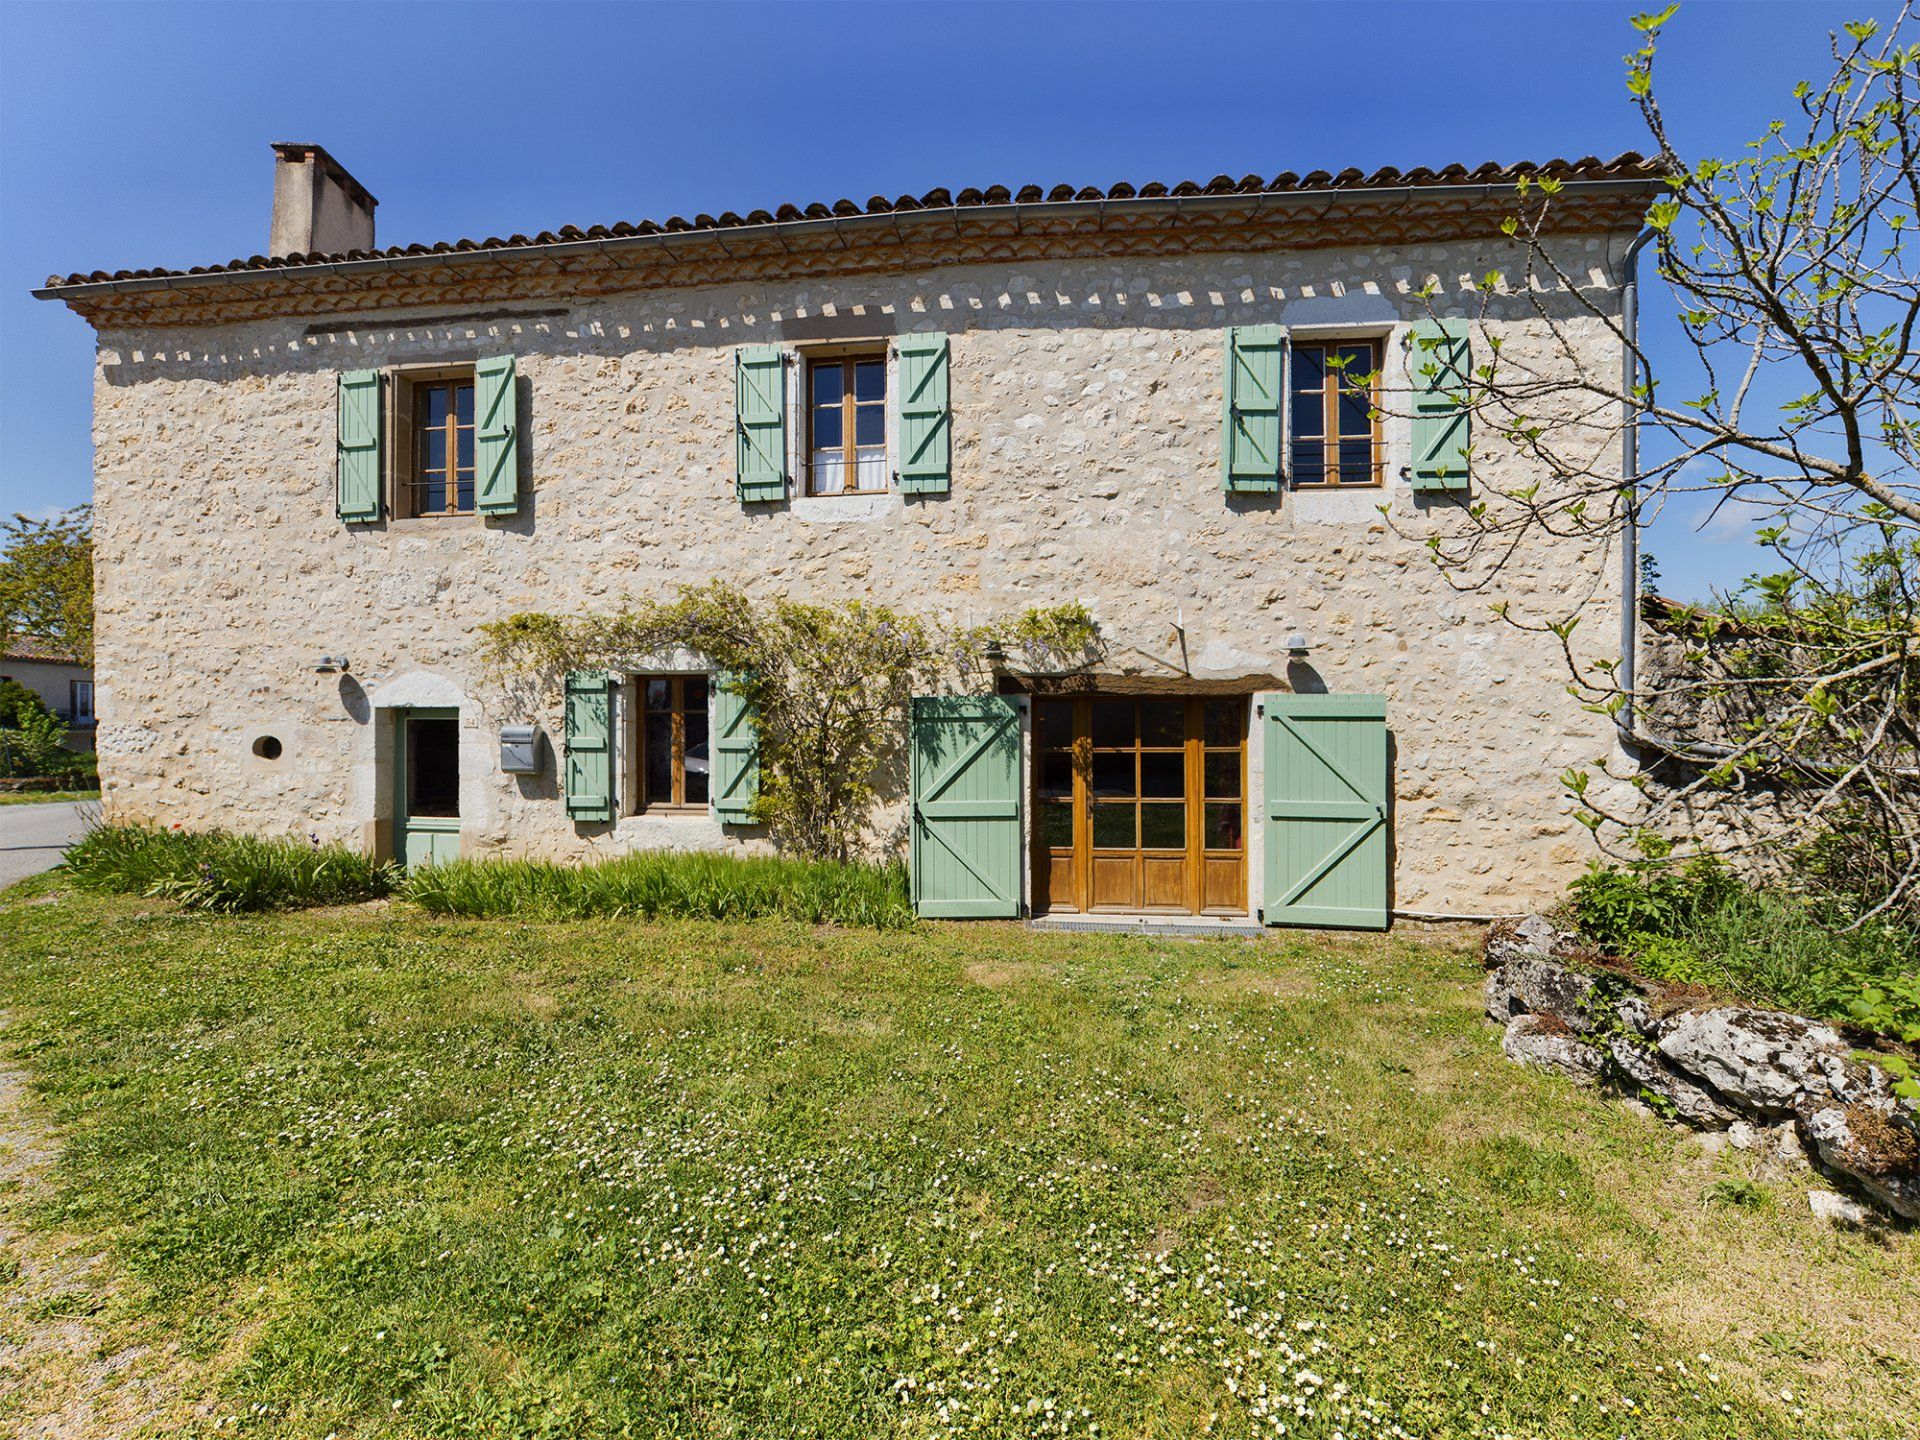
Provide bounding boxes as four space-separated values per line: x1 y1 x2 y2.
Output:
36 146 1659 924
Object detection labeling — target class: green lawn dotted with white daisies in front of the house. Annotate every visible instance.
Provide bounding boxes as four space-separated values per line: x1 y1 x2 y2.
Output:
0 876 1920 1440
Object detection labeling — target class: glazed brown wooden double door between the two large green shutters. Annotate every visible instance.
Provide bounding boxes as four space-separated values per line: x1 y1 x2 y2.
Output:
1033 695 1248 914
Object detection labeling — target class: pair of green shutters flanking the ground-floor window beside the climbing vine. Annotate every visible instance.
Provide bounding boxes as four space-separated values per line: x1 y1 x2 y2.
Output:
561 670 760 826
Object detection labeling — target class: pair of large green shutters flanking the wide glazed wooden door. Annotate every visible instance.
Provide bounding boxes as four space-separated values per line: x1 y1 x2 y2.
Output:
910 693 1390 929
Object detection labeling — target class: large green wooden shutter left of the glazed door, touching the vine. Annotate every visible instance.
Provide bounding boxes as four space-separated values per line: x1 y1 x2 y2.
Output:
912 695 1021 918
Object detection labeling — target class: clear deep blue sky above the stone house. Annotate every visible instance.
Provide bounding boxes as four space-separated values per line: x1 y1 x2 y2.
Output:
0 0 1893 593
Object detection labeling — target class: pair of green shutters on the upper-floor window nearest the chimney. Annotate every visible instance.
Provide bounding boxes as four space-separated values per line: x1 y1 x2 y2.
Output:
334 355 520 524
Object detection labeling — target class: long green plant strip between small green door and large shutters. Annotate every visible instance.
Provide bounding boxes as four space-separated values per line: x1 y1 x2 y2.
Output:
401 851 914 929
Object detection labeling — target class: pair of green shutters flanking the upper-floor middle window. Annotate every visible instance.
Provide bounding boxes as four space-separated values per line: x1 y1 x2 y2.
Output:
733 332 952 505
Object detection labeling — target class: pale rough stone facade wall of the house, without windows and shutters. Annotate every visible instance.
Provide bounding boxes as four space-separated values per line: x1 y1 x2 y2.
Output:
78 236 1620 912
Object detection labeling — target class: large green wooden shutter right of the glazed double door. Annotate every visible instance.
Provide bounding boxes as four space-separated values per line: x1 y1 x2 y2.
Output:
1260 695 1388 929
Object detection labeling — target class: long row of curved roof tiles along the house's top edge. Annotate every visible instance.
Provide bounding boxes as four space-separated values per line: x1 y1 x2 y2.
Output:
46 152 1661 290
